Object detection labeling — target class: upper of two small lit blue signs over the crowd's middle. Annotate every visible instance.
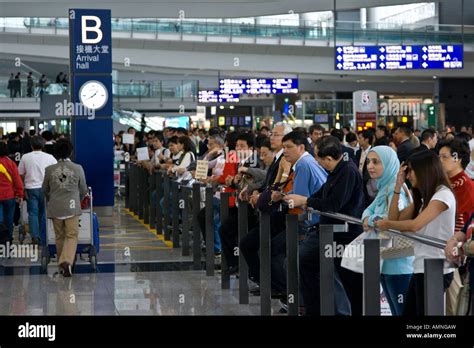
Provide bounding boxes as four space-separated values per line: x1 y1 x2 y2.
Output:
219 78 298 94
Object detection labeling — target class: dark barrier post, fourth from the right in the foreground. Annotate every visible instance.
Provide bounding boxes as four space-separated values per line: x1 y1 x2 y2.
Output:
286 214 299 316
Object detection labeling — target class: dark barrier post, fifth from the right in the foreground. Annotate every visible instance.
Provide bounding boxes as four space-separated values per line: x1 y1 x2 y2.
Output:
260 213 272 315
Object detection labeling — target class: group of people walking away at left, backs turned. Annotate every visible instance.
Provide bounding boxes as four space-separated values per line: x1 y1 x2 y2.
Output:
0 127 88 277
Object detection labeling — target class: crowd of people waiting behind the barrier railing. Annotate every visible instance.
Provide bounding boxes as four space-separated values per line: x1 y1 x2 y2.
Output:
122 124 474 315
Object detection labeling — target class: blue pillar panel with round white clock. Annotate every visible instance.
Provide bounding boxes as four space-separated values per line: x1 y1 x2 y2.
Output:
72 75 113 117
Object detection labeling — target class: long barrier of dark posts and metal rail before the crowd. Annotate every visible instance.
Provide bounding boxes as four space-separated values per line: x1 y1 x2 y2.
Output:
125 162 452 316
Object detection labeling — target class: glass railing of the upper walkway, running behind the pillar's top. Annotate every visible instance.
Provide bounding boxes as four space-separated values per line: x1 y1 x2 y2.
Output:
0 18 474 45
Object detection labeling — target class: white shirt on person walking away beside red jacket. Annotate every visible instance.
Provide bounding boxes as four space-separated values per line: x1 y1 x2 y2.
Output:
18 151 58 189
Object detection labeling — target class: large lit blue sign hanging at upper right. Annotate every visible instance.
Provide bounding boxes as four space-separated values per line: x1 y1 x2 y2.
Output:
335 45 463 71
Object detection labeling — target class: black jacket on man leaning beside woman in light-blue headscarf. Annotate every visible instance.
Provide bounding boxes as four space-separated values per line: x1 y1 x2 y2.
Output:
307 160 364 239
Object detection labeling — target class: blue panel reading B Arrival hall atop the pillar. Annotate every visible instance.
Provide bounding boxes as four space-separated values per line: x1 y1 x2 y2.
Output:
69 9 112 74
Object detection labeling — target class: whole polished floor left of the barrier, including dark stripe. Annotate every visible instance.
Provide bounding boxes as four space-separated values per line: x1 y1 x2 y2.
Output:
0 200 280 315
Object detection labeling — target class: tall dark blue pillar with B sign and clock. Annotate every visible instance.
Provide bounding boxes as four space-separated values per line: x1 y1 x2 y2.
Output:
69 9 114 208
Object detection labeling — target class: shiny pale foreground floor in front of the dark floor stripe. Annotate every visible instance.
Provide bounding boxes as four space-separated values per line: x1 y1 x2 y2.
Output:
0 271 286 315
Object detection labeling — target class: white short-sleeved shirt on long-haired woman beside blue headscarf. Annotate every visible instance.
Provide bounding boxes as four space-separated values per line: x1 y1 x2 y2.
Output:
413 186 456 274
